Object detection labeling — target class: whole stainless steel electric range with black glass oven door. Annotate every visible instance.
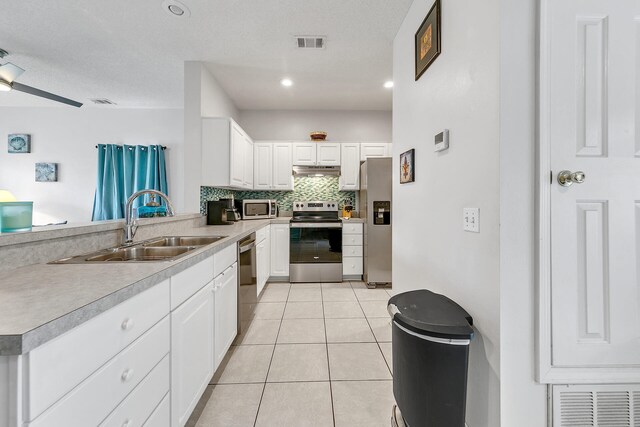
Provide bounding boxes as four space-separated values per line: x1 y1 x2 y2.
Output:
289 201 342 282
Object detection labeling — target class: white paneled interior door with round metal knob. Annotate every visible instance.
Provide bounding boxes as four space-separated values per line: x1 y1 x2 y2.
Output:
541 0 640 372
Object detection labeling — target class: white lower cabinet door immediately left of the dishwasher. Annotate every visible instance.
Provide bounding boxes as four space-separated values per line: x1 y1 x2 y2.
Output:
214 263 238 371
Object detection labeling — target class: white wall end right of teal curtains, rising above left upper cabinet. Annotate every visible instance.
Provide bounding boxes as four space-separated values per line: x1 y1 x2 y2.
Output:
184 61 240 212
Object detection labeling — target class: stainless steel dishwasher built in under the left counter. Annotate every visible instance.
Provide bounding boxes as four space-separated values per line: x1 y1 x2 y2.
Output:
238 233 258 335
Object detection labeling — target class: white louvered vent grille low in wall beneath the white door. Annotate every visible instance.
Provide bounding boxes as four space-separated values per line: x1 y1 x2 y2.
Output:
552 384 640 427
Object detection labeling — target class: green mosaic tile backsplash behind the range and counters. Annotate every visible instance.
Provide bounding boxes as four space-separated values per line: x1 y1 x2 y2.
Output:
200 176 356 214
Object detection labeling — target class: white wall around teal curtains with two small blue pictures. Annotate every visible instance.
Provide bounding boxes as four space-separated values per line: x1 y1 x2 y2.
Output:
0 107 184 224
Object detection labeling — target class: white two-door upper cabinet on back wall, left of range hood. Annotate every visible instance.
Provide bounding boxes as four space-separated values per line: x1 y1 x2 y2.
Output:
253 141 293 190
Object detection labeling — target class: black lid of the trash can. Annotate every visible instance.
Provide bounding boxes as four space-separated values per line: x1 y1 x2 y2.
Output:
387 289 473 339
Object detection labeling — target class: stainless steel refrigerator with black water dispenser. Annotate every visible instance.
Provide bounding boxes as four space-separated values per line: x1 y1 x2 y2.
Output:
360 157 392 287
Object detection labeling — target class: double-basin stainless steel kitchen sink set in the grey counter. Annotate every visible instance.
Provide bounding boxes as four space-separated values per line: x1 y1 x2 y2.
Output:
49 236 227 264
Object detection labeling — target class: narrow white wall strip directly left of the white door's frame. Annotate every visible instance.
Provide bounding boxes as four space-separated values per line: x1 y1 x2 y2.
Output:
500 0 547 427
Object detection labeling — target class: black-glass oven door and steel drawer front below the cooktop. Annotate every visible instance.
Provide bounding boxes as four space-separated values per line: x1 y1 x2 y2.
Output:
289 222 342 282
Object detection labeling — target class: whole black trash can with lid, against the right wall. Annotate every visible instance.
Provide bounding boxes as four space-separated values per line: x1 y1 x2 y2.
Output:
387 290 473 427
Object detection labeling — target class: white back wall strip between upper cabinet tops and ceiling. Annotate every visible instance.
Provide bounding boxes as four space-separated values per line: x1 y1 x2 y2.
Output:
240 110 391 142
